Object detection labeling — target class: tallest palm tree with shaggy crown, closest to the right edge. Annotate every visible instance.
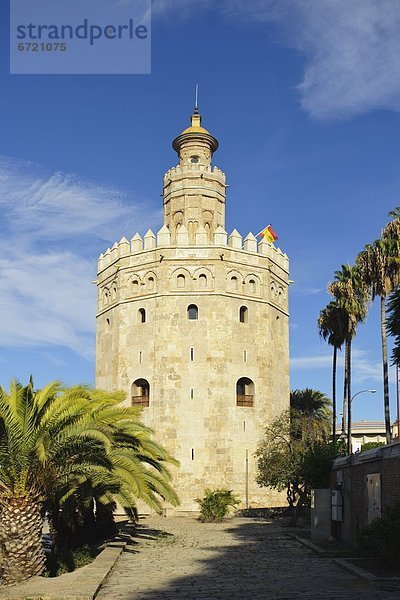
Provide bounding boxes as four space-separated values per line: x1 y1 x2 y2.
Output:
357 234 400 444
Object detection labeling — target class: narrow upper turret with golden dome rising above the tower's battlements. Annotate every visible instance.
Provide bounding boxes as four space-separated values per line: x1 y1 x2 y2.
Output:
163 102 226 244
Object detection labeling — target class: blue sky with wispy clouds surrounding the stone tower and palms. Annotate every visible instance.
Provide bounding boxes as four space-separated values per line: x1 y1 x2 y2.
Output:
0 0 400 420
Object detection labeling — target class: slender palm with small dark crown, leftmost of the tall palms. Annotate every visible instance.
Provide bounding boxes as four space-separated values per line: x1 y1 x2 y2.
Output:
318 302 347 445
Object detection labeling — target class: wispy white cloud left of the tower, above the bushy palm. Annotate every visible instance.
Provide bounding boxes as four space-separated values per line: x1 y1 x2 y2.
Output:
0 157 158 357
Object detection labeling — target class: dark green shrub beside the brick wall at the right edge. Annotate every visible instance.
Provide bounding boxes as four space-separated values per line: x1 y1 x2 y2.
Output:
359 502 400 570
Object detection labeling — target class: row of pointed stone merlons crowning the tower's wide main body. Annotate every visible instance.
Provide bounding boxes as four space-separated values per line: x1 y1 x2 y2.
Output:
97 225 289 275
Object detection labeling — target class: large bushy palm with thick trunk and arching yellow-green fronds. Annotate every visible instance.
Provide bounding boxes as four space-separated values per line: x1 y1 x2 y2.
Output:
0 381 178 583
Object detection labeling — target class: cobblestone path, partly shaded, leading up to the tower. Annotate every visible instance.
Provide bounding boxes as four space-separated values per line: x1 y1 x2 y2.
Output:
96 517 400 600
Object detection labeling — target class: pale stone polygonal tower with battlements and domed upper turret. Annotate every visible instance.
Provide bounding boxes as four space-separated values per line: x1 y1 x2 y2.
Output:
96 109 289 511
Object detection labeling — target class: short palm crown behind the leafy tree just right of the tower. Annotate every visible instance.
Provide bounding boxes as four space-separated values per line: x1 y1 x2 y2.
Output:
290 388 332 441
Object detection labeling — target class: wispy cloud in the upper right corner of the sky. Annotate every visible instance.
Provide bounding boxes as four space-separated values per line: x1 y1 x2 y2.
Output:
154 0 400 120
